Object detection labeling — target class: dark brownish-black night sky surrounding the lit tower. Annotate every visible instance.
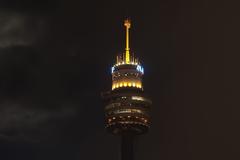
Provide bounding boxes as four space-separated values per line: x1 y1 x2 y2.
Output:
0 0 240 160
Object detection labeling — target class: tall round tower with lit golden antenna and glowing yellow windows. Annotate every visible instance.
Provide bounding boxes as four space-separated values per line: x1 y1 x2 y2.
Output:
102 19 152 160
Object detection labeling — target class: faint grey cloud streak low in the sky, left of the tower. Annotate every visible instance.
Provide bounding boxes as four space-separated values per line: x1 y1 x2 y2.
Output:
0 102 76 143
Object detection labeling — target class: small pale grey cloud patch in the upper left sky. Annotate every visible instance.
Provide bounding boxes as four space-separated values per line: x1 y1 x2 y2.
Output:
0 11 45 48
